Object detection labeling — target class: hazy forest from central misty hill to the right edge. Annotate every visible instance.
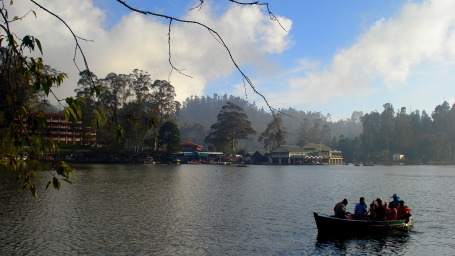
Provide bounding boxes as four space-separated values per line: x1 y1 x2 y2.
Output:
177 94 455 163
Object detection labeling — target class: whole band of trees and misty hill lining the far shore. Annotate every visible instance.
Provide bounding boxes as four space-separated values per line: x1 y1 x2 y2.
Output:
9 74 455 162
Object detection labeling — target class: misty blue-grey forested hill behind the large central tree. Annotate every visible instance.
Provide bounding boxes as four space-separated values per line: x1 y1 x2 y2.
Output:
177 94 362 151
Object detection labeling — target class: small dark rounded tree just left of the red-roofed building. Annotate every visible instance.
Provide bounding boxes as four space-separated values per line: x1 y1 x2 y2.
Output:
158 121 181 161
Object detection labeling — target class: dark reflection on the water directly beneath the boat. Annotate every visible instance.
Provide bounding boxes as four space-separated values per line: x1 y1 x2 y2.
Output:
315 232 410 255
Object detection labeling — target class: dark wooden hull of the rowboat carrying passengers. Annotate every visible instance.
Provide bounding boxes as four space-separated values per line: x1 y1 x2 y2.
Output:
313 212 412 233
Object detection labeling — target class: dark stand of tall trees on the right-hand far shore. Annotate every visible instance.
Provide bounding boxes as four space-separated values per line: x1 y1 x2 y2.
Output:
359 101 455 162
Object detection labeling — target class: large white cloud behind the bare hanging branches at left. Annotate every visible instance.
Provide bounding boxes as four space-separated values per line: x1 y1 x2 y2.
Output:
9 0 292 103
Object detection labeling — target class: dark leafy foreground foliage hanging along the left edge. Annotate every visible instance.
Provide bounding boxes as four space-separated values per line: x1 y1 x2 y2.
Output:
0 0 76 197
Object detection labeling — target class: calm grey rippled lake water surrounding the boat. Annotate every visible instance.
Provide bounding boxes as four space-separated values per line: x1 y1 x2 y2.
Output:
0 165 455 255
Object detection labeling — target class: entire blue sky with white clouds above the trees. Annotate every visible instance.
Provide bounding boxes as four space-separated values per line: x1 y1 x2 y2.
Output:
10 0 455 120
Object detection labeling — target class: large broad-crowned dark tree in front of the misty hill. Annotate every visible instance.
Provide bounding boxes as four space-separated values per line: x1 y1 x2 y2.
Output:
205 102 256 154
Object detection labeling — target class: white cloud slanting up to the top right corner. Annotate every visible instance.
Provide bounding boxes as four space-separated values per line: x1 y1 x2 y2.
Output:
281 0 455 104
